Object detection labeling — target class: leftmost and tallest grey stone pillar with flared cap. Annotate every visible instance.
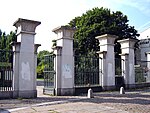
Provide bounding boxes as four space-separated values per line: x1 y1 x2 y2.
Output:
14 18 40 98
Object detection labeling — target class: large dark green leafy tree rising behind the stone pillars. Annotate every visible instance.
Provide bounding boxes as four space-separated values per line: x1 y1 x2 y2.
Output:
69 7 139 54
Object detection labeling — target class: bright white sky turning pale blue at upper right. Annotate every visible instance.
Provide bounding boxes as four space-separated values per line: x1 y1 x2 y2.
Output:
0 0 150 51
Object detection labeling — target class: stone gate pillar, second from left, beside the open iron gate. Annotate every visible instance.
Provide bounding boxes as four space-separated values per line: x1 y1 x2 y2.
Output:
53 26 75 95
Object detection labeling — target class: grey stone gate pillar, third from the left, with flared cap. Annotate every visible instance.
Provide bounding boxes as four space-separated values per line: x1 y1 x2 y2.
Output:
96 34 117 90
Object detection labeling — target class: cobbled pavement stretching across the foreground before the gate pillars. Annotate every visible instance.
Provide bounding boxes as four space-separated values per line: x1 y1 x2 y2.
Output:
0 83 150 113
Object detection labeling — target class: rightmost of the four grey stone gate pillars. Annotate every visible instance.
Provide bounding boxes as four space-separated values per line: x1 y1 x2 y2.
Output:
118 39 137 88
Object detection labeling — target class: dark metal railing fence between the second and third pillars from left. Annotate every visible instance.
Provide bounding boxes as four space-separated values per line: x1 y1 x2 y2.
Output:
74 56 102 87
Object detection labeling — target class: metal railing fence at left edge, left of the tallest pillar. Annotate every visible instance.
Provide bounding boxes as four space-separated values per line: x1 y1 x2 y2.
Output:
0 50 13 91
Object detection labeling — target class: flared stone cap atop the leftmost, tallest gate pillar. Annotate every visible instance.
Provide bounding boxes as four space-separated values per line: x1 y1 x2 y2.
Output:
13 18 41 33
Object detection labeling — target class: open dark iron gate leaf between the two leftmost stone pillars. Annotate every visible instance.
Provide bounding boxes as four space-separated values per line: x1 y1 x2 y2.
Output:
43 55 56 95
